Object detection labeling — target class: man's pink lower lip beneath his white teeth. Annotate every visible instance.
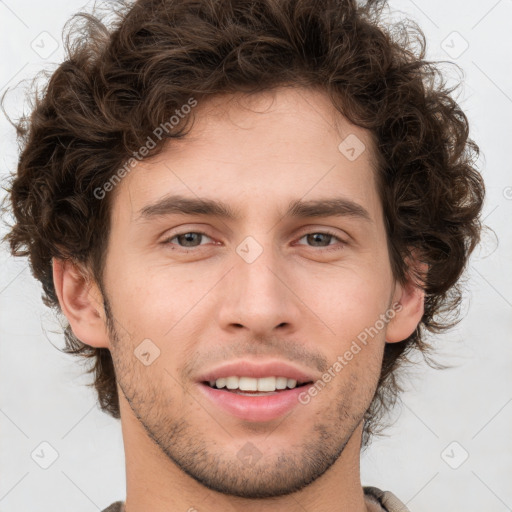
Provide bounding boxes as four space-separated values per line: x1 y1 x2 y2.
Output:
199 383 307 421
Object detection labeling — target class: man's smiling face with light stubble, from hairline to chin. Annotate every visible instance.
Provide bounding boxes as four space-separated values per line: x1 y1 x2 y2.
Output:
98 89 400 498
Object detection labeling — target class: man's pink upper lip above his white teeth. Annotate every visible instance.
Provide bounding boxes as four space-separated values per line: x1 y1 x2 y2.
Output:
198 360 315 383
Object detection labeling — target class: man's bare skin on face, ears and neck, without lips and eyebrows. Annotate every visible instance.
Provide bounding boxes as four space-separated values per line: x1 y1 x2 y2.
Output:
54 88 424 512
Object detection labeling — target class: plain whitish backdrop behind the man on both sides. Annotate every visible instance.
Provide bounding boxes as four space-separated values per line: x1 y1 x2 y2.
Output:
0 0 512 512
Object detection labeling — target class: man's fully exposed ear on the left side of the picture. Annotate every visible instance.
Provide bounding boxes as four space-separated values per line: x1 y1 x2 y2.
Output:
53 258 110 348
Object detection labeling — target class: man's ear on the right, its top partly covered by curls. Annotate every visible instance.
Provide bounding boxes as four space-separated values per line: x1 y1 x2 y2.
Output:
386 252 428 343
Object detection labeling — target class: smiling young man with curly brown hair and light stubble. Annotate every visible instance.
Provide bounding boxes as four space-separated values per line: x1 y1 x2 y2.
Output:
7 0 484 512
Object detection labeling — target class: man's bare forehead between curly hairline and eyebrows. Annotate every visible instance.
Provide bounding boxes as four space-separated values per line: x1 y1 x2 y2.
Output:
115 88 380 222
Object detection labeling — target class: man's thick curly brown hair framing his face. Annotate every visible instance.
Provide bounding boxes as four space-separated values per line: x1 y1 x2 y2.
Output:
5 0 484 447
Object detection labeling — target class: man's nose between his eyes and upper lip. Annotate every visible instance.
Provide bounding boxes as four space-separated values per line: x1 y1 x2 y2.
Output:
217 241 301 337
